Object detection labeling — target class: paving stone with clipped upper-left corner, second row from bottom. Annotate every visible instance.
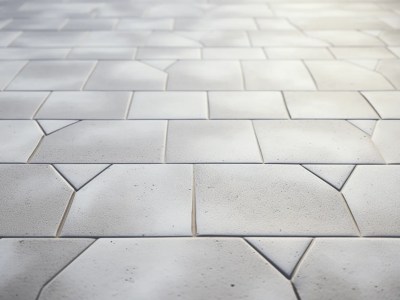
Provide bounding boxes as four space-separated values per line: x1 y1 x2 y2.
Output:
62 165 193 236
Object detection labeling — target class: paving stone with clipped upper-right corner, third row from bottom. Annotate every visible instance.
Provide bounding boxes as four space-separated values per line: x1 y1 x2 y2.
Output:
254 120 383 164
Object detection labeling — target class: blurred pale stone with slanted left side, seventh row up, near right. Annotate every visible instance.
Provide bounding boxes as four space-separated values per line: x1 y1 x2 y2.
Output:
306 30 384 47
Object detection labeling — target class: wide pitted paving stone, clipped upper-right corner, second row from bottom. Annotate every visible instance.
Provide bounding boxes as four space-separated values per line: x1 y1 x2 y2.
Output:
195 164 357 236
